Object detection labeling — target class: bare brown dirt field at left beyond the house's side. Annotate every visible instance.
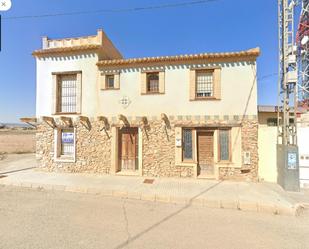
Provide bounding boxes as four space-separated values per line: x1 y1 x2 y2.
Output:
0 129 35 156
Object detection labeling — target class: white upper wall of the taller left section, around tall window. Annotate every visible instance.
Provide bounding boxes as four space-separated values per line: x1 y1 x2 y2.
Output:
36 53 98 116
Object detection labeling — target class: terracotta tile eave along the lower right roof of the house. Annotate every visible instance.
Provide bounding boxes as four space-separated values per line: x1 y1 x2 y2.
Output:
97 48 260 67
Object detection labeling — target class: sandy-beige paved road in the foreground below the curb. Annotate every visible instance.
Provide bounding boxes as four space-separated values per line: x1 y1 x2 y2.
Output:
0 186 309 249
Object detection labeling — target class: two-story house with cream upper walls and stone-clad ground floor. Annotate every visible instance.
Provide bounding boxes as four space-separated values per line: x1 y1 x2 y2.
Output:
33 30 260 180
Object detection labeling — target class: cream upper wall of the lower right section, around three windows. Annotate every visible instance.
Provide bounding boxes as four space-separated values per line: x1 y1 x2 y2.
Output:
98 63 257 116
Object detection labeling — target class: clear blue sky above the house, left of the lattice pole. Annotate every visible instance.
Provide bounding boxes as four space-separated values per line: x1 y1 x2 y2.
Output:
0 0 278 123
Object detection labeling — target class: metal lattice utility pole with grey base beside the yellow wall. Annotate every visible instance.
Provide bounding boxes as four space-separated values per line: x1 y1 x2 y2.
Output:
277 0 299 191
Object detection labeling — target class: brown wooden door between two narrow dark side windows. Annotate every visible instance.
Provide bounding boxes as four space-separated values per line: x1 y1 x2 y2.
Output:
197 131 214 176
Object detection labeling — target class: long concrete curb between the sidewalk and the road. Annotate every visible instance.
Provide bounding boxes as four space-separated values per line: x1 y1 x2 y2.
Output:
0 182 300 216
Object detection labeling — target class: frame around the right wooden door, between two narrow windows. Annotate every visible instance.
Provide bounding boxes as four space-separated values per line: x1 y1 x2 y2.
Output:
196 128 217 179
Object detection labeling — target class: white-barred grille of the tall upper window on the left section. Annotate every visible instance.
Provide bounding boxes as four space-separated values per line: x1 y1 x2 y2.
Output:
58 74 77 113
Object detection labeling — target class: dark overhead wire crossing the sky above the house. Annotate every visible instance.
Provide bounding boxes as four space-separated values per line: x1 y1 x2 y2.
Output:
2 0 220 20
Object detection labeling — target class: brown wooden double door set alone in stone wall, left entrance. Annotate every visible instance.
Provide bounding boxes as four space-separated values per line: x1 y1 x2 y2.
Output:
119 128 138 171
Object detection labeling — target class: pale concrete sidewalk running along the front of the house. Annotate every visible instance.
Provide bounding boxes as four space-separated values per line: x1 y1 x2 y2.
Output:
0 155 303 215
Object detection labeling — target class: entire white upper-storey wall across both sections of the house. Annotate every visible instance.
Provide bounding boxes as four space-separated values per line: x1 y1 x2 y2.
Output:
36 53 257 117
